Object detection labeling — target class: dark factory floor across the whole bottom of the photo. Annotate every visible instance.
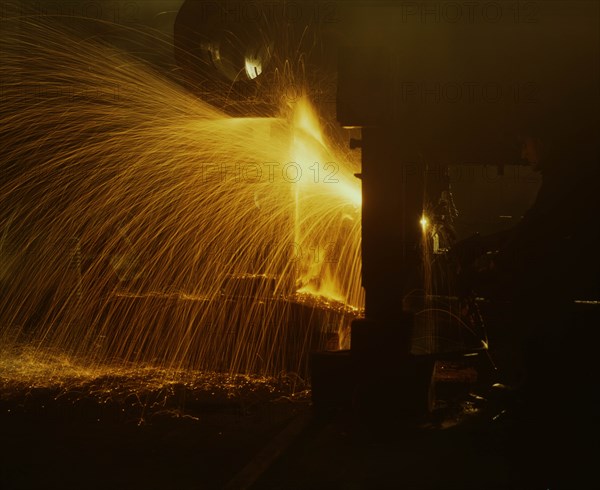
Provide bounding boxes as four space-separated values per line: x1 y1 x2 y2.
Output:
0 356 597 490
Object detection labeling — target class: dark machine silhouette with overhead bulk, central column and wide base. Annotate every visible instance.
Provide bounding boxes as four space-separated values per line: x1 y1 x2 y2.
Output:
170 0 599 422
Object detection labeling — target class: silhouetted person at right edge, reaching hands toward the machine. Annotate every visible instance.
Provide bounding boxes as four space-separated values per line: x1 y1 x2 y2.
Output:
456 108 600 407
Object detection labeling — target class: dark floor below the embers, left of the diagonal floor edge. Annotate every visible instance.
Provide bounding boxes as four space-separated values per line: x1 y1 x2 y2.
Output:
0 371 309 490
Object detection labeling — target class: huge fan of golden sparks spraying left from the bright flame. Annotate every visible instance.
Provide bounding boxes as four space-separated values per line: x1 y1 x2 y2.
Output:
0 18 363 374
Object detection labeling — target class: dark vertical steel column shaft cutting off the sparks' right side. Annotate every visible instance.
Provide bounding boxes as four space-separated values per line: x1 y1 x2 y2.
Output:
362 125 423 324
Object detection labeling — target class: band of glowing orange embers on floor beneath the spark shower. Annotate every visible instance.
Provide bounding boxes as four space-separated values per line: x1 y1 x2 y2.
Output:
0 346 308 425
